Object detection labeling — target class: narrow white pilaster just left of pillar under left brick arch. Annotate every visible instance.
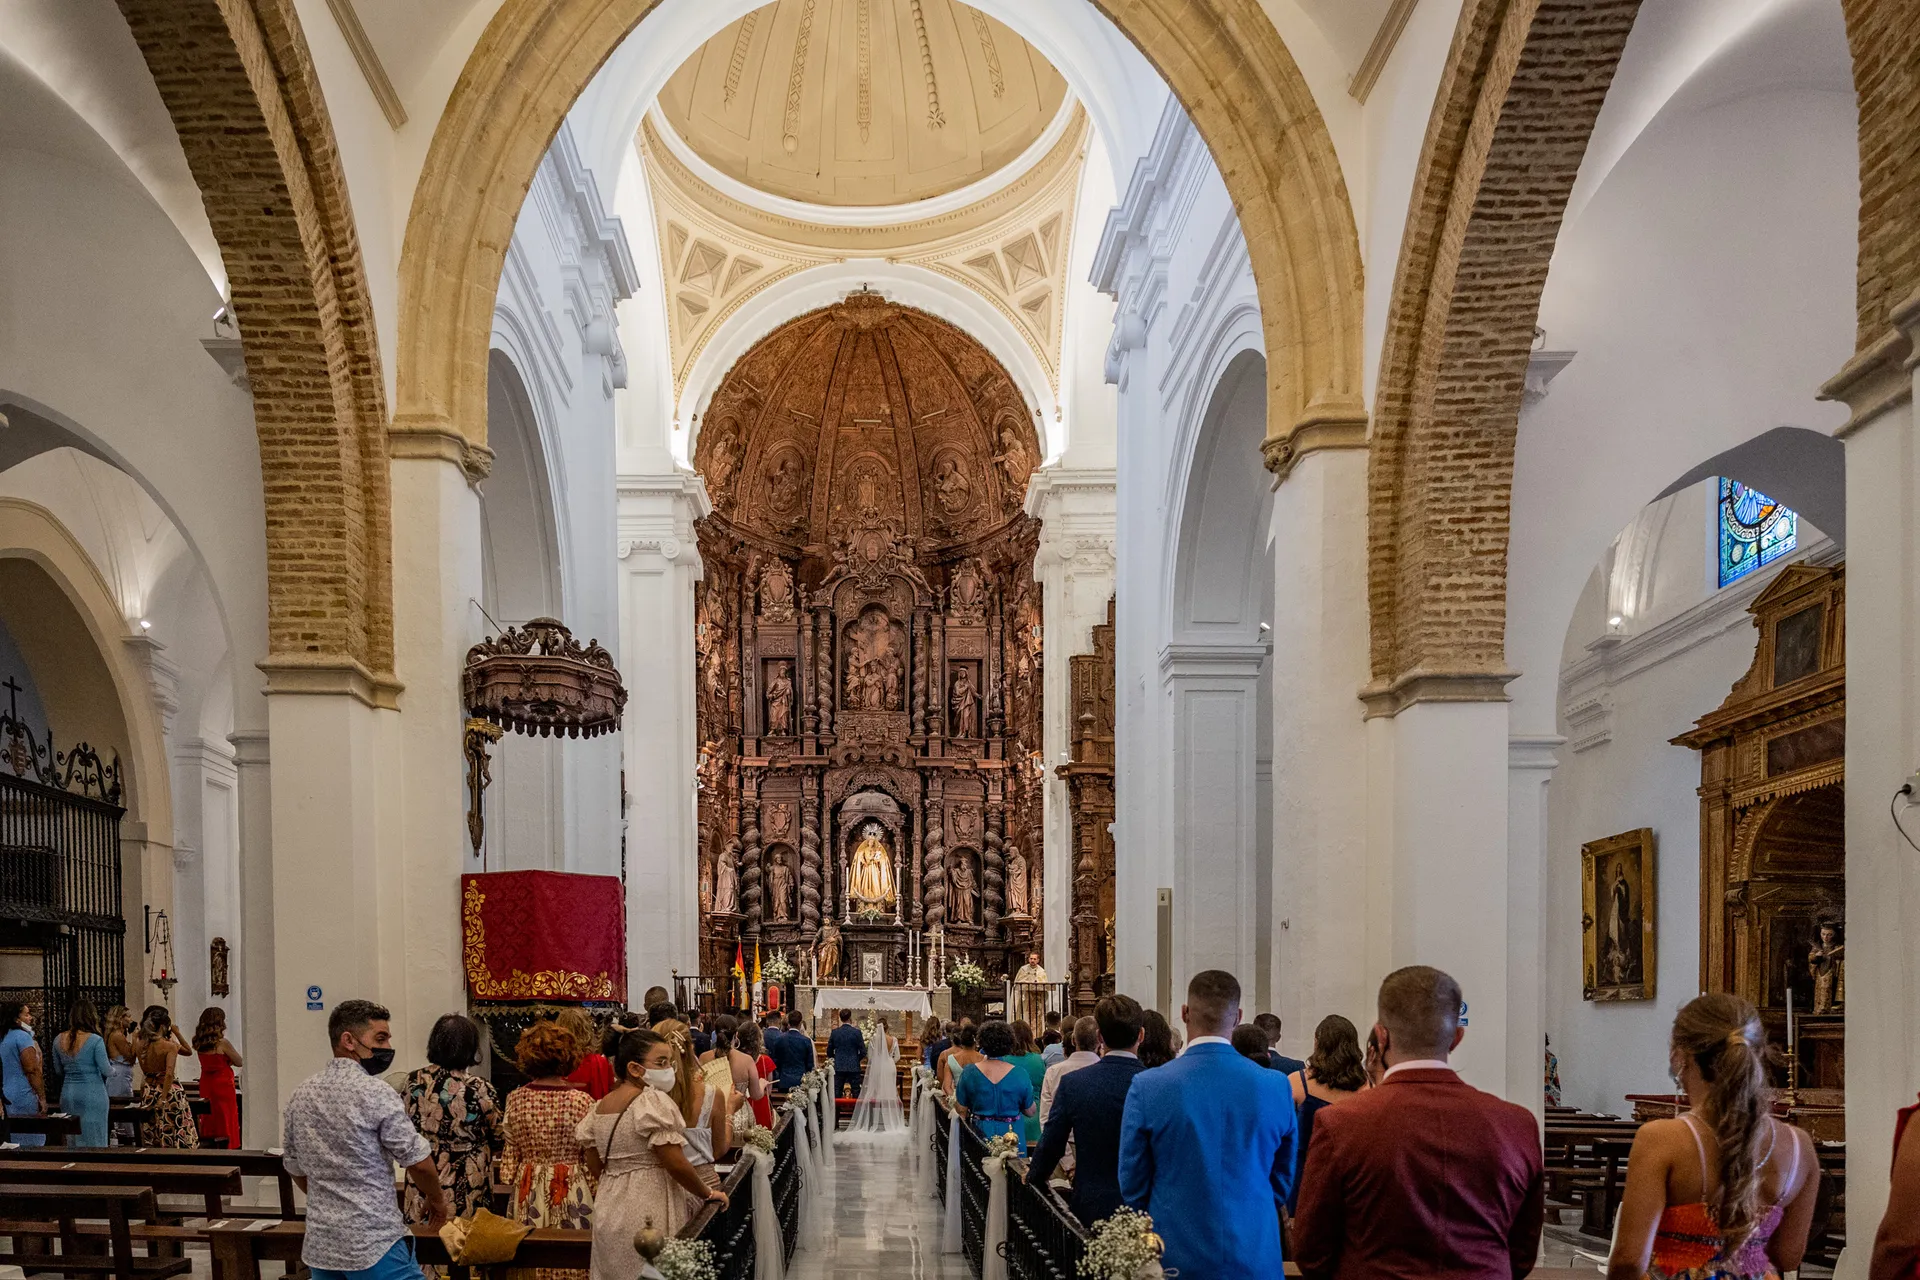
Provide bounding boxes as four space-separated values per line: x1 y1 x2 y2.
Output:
227 729 282 1151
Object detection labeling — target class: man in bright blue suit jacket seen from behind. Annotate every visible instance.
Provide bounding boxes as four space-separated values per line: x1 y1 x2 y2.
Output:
1121 969 1296 1280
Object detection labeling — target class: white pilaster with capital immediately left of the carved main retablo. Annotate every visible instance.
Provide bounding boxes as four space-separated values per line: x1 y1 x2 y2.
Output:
618 472 712 996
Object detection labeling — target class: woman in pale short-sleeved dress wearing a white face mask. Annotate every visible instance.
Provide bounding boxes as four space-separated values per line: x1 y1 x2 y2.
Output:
574 1031 728 1280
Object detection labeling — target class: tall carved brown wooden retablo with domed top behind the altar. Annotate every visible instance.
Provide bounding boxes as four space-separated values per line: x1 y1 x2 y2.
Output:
695 292 1043 983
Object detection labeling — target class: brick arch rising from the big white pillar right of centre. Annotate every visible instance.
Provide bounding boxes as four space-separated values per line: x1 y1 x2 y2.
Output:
1365 0 1640 714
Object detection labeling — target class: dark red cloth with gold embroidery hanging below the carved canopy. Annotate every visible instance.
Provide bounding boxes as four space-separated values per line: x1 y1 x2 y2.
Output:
461 871 626 1000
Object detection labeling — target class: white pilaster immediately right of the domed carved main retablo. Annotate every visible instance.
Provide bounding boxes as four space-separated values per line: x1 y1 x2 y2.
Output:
1021 468 1114 979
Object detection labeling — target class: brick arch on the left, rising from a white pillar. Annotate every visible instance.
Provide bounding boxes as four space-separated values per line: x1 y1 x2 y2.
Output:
119 0 396 690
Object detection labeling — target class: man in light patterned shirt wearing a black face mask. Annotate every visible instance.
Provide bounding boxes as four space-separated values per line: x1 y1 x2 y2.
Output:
284 1000 453 1280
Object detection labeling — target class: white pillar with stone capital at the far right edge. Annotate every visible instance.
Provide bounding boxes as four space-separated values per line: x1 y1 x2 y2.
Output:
1824 296 1920 1280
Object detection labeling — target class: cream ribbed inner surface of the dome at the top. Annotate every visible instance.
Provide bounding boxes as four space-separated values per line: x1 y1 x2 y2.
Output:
660 0 1068 205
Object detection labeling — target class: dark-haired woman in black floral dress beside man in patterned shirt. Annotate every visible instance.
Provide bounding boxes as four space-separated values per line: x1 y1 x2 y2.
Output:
405 1013 501 1222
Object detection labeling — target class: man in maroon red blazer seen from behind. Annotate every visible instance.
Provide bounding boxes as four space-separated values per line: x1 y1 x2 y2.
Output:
1294 965 1546 1280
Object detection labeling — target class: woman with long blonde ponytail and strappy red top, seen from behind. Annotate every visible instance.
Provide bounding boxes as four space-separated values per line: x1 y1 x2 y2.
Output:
1607 994 1820 1280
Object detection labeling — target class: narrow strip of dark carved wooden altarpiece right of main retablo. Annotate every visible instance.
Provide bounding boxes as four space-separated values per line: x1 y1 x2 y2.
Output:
1056 597 1114 1013
